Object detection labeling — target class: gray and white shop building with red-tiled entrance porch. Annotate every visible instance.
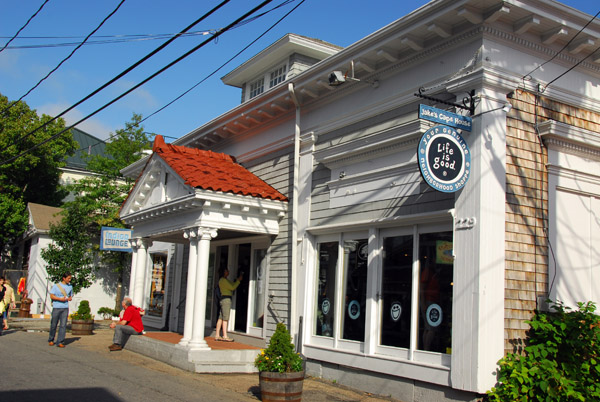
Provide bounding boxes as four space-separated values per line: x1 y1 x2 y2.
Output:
121 0 600 402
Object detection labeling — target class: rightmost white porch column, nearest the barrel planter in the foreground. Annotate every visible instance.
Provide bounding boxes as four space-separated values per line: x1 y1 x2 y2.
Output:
189 228 217 349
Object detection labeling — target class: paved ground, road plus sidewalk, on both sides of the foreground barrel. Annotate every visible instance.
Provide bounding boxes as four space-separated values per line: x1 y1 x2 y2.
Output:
0 328 393 402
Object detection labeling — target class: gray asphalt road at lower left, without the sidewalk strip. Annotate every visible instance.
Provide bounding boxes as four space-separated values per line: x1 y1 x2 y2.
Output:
0 331 256 402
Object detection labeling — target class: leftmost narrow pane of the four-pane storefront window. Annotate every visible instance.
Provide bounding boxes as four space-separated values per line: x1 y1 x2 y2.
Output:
315 242 338 337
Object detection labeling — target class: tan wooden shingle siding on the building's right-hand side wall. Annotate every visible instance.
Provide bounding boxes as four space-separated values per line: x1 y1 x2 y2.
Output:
504 91 600 352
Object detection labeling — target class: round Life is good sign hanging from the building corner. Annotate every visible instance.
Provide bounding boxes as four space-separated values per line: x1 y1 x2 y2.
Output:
417 126 471 193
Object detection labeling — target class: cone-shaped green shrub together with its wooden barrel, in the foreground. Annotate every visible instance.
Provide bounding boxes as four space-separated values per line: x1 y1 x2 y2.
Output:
254 323 304 402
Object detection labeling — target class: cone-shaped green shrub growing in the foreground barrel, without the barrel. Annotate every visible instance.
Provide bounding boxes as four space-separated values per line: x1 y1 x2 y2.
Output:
254 323 303 373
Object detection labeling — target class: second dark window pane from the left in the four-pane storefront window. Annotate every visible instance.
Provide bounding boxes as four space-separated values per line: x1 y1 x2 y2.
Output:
342 239 369 341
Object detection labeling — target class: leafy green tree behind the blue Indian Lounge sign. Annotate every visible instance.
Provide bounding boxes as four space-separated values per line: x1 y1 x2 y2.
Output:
55 114 151 302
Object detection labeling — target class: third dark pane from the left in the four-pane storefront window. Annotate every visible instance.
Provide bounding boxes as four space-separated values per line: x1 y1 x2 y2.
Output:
381 235 413 348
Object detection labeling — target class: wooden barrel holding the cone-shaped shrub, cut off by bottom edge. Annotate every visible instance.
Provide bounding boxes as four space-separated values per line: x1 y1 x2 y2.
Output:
259 371 304 402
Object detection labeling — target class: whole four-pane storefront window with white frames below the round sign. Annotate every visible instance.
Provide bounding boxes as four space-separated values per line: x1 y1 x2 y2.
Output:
313 224 454 362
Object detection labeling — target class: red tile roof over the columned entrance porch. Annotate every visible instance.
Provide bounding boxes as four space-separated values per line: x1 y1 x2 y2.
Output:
152 135 288 201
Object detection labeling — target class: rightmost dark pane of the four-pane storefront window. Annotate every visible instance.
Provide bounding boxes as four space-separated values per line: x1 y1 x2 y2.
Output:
417 232 454 353
